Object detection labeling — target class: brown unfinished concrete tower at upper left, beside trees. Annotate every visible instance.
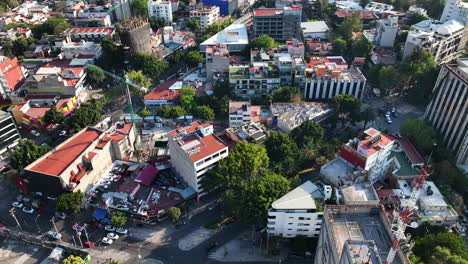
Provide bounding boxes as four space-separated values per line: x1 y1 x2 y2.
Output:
117 19 152 55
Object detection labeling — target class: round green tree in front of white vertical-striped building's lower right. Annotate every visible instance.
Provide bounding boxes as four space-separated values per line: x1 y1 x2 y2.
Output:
332 94 361 125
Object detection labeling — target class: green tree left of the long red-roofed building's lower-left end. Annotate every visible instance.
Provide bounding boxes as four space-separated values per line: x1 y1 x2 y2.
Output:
10 140 50 171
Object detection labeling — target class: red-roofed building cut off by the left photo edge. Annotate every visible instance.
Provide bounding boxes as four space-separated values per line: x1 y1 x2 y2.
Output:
0 56 26 102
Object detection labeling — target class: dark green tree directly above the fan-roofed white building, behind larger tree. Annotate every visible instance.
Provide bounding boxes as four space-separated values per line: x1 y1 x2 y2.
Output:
265 132 301 176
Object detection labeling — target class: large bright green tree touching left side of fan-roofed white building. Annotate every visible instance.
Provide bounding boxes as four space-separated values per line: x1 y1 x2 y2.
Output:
237 172 289 224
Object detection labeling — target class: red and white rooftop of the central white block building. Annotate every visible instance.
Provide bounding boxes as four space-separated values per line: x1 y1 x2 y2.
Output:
168 121 227 162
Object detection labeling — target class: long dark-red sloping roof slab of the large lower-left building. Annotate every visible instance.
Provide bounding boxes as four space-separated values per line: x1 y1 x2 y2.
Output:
26 127 102 176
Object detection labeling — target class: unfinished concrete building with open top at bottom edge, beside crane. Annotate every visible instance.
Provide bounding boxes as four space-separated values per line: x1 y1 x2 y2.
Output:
315 205 412 264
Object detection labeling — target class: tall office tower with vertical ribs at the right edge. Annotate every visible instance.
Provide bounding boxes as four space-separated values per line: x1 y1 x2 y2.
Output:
424 58 468 165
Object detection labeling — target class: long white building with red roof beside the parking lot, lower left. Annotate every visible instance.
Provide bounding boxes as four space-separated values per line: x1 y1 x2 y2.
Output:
22 124 134 195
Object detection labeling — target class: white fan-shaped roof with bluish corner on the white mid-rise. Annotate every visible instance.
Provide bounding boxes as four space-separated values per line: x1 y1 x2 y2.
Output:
271 181 323 210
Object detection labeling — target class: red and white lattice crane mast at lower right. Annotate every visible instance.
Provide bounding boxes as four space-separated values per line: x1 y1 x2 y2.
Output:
385 164 429 264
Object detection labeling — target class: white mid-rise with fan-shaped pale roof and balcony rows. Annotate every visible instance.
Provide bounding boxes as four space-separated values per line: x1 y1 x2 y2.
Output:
267 181 325 238
